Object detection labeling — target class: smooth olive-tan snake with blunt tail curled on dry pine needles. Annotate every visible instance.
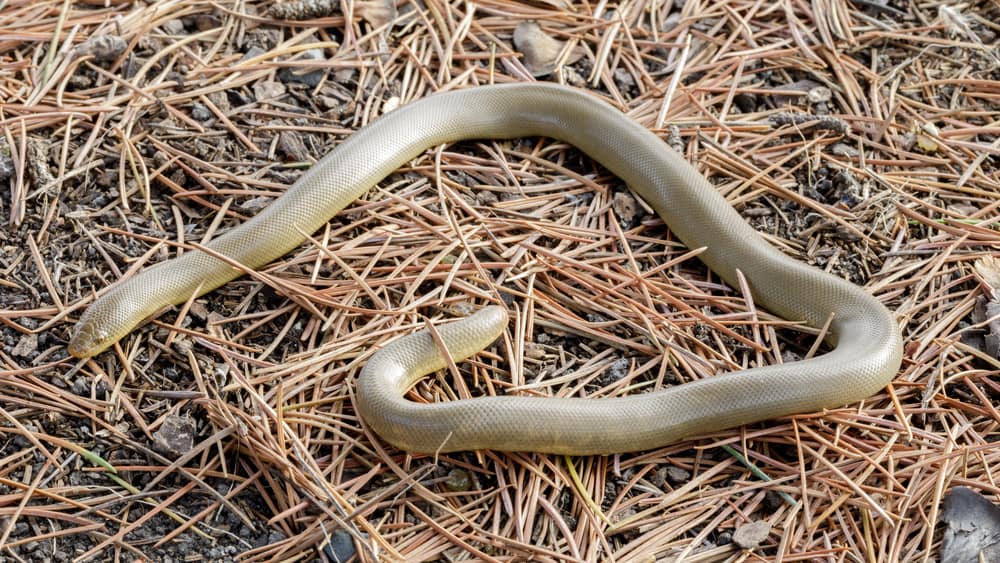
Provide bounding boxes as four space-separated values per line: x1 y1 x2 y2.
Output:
67 83 902 455
